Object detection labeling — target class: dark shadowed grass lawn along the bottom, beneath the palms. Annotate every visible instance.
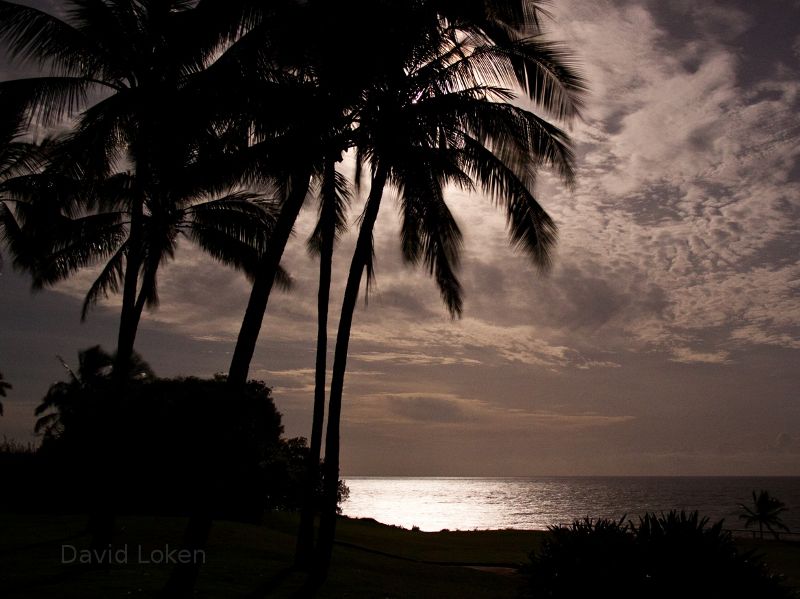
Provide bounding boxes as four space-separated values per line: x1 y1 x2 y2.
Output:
0 513 800 599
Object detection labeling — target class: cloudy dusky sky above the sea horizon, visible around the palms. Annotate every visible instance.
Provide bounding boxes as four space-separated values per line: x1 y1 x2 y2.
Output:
0 0 800 476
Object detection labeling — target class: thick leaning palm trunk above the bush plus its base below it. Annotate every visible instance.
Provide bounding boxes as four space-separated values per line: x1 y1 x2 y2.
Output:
162 171 310 598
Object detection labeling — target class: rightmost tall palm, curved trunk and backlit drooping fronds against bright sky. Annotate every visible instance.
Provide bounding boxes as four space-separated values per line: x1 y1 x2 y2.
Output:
318 4 582 577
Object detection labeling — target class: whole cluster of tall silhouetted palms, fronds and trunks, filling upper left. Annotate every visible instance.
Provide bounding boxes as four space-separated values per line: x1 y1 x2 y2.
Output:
0 0 584 584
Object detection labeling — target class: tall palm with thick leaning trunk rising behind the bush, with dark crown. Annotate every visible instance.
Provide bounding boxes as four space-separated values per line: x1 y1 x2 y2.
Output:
219 0 490 385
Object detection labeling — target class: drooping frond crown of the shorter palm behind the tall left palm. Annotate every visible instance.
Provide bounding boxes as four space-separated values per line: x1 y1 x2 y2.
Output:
0 142 290 320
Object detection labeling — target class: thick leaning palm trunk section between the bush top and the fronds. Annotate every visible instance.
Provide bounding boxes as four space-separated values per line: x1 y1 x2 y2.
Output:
228 172 310 387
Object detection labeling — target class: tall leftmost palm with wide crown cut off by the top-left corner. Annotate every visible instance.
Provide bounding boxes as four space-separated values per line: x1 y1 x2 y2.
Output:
0 0 274 380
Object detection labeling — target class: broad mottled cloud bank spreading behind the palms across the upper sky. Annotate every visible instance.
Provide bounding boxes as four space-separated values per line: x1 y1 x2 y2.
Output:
45 2 800 369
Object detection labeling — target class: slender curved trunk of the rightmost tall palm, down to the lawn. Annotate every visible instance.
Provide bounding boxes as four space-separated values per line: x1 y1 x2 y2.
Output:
315 167 387 583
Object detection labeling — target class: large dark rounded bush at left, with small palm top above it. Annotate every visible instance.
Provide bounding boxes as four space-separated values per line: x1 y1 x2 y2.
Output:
0 346 344 520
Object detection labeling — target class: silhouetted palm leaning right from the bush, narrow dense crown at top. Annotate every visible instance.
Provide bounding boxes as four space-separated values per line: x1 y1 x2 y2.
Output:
222 0 366 390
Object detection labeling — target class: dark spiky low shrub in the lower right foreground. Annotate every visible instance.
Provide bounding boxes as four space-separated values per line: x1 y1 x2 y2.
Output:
527 511 792 599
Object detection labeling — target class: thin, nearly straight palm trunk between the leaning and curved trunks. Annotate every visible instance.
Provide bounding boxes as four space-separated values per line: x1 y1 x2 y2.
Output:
295 159 336 567
